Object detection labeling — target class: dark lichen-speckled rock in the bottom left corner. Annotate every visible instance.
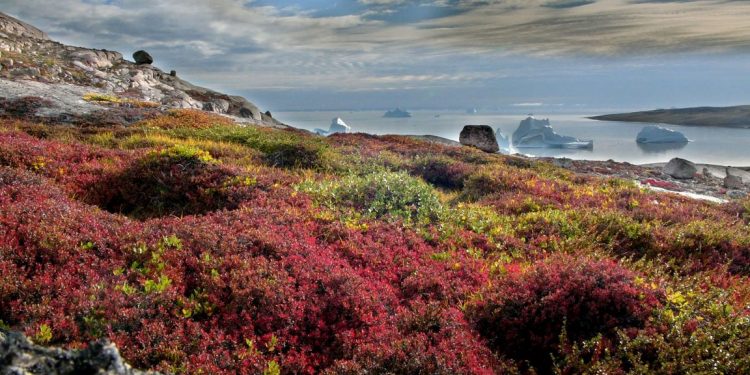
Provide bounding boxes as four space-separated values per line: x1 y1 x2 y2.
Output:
0 329 156 375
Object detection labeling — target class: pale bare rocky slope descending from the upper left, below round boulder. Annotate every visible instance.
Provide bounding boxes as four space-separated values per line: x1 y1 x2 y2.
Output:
0 13 286 127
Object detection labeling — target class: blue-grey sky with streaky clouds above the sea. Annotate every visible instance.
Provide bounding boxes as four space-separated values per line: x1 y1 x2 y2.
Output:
0 0 750 113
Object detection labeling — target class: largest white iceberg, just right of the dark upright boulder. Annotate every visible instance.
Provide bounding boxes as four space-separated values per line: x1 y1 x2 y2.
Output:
512 116 594 148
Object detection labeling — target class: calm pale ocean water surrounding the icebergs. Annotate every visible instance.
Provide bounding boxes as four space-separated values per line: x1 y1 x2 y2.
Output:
274 111 750 166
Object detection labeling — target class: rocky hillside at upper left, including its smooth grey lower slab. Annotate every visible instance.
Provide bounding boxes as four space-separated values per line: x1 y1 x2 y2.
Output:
0 13 285 127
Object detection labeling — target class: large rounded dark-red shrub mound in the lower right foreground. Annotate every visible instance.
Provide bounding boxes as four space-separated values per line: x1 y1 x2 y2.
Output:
468 255 662 370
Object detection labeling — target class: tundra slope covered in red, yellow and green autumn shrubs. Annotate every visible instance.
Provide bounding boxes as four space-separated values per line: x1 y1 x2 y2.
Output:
0 11 750 375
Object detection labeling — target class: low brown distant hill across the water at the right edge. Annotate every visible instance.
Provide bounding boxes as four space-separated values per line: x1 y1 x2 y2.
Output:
590 105 750 128
